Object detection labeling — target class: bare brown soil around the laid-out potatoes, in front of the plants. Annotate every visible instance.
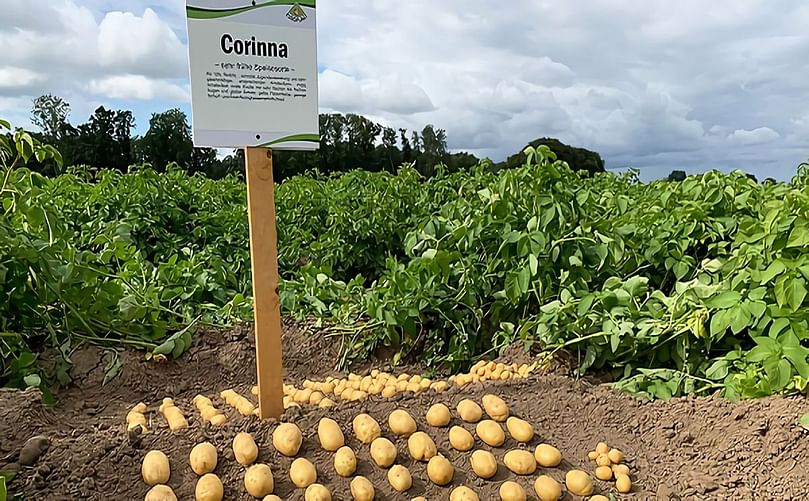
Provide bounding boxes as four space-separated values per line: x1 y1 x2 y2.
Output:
0 323 809 501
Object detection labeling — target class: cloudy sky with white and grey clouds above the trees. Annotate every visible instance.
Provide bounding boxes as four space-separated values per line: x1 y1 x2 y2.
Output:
0 0 809 180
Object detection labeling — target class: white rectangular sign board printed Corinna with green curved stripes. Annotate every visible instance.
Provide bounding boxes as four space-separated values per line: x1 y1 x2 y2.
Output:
186 0 320 150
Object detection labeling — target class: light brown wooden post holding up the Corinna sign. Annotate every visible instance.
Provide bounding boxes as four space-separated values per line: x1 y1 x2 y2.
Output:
244 148 284 419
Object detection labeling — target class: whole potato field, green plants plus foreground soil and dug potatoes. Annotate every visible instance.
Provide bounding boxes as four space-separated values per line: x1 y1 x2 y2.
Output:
0 124 809 501
